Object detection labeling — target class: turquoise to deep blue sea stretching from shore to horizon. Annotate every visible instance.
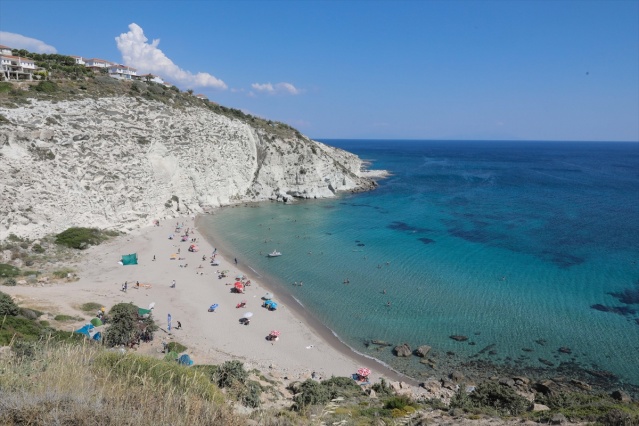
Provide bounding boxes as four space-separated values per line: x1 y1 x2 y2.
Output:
200 139 639 389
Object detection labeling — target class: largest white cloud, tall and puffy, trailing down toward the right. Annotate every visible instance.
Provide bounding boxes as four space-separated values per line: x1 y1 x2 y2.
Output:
115 23 226 89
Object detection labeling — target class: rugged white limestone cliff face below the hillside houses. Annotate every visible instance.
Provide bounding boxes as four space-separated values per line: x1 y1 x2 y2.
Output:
0 96 382 239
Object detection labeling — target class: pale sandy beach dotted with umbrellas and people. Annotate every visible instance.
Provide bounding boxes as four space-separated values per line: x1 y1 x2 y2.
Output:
7 217 414 384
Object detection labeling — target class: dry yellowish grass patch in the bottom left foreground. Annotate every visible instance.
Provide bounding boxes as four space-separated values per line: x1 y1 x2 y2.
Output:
0 341 245 426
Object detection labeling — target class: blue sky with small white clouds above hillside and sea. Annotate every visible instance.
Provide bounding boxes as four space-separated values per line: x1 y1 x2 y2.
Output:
0 0 639 141
